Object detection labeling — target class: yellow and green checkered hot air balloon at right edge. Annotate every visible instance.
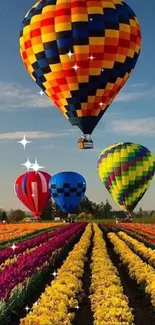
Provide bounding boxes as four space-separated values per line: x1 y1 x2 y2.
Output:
97 142 155 211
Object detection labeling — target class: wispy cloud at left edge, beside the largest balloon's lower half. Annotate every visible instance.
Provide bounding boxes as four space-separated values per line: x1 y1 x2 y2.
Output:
0 83 52 111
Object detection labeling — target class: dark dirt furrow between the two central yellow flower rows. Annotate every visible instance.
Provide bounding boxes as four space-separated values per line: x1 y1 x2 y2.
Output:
72 235 93 325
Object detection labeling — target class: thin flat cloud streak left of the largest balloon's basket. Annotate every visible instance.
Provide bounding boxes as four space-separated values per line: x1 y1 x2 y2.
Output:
0 131 70 141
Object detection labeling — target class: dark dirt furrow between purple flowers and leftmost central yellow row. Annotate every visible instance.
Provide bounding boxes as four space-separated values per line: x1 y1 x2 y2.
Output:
6 235 81 325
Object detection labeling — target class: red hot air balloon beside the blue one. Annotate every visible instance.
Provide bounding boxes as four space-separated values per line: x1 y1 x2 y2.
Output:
14 171 51 218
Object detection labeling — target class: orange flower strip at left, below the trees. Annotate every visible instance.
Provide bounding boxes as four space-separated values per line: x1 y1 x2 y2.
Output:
0 222 61 244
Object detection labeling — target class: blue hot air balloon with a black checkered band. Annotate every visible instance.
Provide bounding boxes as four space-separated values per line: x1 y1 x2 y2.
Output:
49 172 86 213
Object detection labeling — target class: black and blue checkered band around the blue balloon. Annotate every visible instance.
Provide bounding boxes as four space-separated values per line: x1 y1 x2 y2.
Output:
50 183 86 198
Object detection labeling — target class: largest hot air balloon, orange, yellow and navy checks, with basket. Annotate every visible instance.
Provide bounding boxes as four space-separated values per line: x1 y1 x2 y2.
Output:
20 0 141 149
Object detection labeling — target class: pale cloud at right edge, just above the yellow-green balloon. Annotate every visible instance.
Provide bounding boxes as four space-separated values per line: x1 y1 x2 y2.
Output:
107 117 155 136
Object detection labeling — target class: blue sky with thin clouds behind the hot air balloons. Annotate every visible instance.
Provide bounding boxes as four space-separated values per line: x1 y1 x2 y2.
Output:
0 0 155 210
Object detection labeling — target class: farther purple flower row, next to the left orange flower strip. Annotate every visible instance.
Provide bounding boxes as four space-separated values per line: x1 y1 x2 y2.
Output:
0 224 75 264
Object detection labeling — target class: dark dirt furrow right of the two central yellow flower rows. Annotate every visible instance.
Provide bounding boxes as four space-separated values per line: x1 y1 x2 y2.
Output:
104 230 155 325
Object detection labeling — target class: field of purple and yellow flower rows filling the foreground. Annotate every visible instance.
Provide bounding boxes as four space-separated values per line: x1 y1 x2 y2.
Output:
0 222 155 325
